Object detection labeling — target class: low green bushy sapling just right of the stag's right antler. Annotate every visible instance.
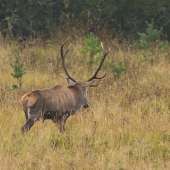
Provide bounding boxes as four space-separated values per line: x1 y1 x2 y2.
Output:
112 61 126 79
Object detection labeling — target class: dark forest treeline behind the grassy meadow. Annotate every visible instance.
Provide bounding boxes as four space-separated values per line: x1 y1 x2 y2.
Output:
0 0 170 40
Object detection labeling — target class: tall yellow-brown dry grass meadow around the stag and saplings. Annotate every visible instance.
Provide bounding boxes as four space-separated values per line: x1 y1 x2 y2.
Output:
0 33 170 170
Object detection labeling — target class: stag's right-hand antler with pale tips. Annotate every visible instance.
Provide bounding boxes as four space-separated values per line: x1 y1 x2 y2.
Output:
88 42 110 87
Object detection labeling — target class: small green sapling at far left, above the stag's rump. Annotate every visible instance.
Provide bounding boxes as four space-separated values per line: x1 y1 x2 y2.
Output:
10 60 26 88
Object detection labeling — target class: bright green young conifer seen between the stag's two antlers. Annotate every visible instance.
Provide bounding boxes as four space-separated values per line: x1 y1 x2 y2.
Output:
79 32 102 64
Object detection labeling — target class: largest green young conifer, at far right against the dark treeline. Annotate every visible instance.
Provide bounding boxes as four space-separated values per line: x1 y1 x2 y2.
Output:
135 19 167 64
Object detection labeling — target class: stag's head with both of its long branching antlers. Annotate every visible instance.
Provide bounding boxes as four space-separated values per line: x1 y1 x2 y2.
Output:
61 38 110 108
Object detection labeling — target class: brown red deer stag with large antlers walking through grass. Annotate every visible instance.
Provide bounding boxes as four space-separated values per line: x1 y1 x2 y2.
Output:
21 38 110 133
